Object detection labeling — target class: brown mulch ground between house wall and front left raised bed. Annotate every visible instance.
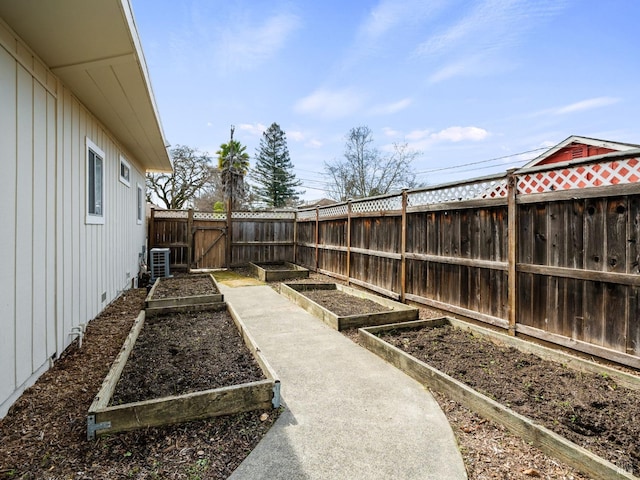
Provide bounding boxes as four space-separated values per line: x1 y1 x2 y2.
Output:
0 289 278 480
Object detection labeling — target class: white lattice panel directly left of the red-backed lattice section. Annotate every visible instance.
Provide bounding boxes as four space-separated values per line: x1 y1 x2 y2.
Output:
407 177 508 207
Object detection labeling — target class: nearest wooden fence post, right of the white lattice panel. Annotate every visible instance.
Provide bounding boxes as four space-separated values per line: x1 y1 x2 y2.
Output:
507 169 518 336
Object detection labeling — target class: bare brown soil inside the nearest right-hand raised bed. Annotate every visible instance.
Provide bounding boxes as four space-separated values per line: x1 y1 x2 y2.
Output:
380 326 640 475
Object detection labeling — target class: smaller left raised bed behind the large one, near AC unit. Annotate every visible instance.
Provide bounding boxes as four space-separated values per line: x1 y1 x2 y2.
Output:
145 274 225 317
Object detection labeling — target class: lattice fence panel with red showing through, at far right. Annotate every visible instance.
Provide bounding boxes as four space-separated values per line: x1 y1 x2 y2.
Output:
518 158 640 195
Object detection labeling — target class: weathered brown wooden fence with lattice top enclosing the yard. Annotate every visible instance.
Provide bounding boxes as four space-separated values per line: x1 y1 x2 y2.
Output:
149 150 640 368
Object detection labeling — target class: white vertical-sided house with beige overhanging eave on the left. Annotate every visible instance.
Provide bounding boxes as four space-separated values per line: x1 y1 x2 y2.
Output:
0 0 172 418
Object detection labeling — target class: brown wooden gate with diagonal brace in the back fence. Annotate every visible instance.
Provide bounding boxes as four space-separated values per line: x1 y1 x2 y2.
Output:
191 218 227 269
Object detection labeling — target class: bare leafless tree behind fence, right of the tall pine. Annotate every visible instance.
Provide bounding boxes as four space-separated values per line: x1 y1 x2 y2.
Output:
325 126 420 201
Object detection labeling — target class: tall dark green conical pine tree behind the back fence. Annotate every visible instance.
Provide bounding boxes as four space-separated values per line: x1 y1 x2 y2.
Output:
250 122 302 208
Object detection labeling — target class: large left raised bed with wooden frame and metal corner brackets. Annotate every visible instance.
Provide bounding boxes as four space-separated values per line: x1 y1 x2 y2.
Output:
87 307 280 439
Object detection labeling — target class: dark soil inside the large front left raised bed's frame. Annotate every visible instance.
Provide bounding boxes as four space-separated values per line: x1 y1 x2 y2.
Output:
112 311 266 405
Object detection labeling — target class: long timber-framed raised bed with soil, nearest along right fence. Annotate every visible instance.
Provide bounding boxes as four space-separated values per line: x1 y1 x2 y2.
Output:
359 318 640 479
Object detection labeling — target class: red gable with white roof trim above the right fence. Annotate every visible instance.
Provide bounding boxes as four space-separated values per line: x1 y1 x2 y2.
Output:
522 135 640 169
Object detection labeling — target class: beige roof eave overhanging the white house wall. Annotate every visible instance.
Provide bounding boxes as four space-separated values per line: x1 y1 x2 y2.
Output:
0 0 172 171
